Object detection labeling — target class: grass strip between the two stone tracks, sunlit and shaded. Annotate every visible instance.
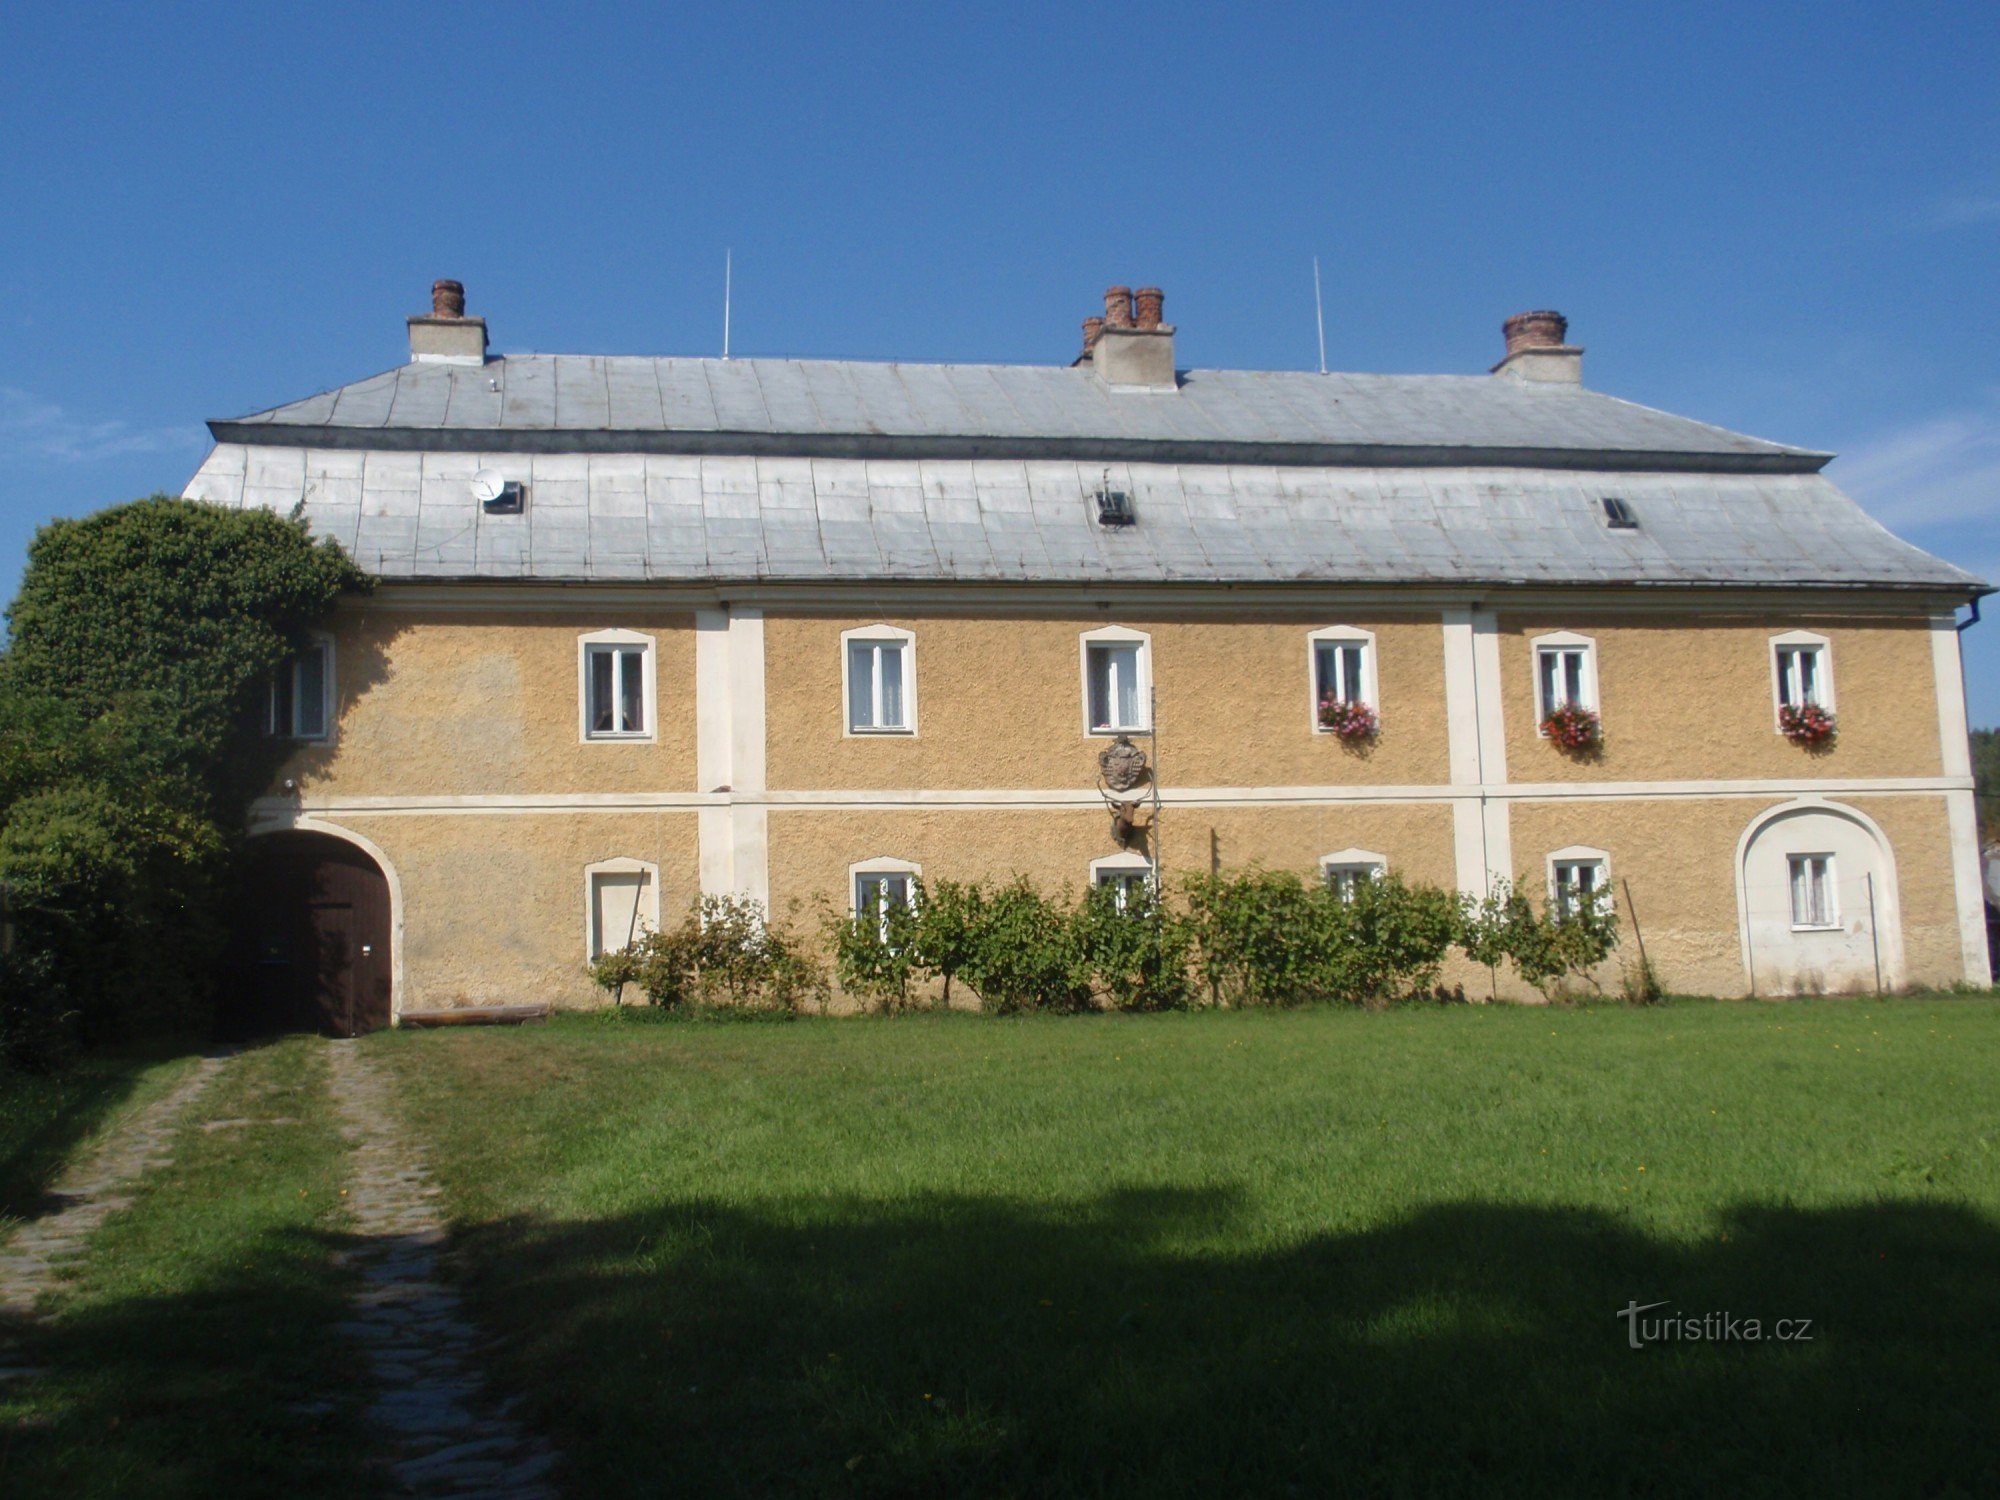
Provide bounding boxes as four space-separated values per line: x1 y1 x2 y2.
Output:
0 1038 380 1500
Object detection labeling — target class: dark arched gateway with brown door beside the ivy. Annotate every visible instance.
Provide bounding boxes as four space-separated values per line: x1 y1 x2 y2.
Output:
226 830 390 1036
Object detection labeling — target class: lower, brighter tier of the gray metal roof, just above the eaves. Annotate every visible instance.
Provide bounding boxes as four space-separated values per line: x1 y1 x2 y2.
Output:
186 444 1986 594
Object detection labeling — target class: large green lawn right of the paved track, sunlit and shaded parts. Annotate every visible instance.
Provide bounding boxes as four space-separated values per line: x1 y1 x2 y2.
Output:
370 1000 2000 1496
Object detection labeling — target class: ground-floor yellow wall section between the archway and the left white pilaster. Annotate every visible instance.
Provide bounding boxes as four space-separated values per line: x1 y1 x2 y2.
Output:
328 812 700 1010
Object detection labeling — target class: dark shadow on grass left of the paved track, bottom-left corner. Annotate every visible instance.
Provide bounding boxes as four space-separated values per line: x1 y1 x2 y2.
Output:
0 1230 386 1500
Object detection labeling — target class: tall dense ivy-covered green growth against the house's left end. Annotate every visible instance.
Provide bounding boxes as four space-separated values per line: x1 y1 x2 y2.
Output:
0 496 366 1060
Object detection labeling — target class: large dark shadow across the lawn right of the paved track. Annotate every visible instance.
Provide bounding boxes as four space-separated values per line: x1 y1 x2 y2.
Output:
454 1190 2000 1496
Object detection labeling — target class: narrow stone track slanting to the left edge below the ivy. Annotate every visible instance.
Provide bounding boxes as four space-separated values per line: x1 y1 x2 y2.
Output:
0 1050 234 1320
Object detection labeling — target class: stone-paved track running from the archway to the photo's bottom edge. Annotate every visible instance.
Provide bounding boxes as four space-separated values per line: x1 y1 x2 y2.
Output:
328 1042 560 1500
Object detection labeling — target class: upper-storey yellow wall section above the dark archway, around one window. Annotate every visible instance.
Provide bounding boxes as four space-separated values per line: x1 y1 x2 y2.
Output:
280 600 694 796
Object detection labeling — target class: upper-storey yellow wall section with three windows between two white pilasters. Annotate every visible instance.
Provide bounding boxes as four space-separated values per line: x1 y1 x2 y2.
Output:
764 614 1448 790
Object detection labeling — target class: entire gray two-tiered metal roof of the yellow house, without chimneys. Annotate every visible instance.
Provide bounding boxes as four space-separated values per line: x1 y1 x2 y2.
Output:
188 356 1986 594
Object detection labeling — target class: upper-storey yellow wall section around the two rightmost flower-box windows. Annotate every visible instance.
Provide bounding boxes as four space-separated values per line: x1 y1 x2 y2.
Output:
1500 614 1942 782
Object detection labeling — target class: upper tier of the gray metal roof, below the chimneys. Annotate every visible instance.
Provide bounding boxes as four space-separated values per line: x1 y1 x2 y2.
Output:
210 354 1828 472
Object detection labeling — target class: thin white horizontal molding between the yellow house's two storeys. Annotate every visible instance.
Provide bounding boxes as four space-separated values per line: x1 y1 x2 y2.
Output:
250 776 1972 826
